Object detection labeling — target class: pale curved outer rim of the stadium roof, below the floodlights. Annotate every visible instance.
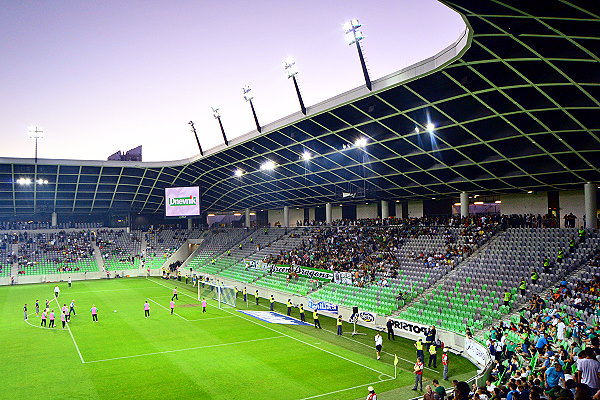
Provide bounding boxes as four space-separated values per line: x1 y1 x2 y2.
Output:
0 16 473 168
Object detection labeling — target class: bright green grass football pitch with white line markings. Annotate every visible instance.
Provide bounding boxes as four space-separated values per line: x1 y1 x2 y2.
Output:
0 278 475 400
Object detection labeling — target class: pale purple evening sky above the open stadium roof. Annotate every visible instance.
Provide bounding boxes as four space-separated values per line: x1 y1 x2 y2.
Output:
0 0 464 161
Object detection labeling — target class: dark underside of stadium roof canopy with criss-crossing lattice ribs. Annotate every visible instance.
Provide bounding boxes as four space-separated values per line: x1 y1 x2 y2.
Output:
0 0 600 215
